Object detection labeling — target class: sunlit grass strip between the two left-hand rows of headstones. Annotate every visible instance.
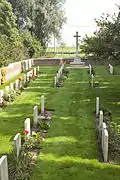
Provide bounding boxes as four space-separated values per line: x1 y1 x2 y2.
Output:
0 67 59 155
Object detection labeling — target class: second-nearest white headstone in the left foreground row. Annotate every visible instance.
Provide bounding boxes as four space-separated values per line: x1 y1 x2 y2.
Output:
14 133 21 158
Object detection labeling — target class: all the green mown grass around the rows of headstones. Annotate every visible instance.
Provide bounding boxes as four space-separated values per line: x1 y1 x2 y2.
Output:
0 66 120 180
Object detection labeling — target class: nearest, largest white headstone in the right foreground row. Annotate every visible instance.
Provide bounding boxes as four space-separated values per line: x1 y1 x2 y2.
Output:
103 129 108 162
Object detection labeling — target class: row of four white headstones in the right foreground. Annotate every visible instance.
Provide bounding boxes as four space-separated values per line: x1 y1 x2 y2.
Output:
96 97 108 162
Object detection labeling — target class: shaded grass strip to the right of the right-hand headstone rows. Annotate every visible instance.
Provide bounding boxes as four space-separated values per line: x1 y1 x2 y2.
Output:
92 66 120 124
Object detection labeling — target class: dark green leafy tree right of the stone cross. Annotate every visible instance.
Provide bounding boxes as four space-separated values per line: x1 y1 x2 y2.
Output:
81 13 120 61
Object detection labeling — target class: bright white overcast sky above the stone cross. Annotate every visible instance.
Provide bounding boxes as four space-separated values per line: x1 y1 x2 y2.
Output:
49 0 120 46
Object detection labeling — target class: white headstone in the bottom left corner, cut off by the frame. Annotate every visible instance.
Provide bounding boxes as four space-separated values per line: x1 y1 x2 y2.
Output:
0 156 8 180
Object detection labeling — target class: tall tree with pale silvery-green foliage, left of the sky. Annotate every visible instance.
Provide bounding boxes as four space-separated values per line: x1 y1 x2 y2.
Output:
9 0 66 47
